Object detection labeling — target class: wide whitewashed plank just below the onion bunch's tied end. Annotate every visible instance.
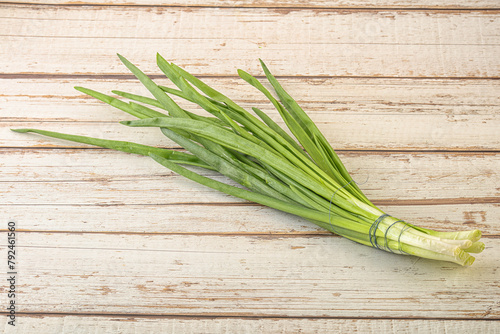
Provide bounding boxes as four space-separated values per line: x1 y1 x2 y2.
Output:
0 232 500 319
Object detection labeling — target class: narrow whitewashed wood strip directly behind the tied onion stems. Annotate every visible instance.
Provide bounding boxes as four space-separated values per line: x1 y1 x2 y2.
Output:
0 202 500 236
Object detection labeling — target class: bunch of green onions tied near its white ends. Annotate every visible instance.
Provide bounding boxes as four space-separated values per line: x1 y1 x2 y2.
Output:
13 54 484 265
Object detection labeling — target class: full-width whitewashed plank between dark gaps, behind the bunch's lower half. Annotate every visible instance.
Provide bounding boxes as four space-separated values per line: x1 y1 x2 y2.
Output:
0 149 500 235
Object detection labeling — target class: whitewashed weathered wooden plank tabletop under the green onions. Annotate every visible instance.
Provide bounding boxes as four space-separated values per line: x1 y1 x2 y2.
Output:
0 0 500 333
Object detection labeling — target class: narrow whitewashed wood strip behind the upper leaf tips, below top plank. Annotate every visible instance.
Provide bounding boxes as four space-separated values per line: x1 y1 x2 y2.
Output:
4 77 500 122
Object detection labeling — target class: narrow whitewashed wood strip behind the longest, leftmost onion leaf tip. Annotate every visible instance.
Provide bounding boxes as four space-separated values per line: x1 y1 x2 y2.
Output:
5 112 500 152
